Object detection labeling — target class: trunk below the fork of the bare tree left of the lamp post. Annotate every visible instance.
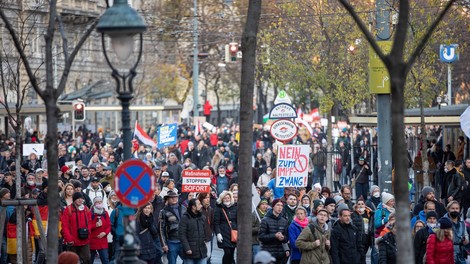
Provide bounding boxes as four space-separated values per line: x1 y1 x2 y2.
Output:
45 100 60 263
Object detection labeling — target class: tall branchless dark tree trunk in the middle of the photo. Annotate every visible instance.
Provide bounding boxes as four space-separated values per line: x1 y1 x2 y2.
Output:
237 0 261 263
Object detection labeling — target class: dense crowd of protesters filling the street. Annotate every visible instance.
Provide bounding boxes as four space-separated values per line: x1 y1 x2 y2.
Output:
0 126 470 264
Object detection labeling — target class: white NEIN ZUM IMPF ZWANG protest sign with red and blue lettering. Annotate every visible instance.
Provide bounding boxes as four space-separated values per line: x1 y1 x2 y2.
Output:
276 145 310 188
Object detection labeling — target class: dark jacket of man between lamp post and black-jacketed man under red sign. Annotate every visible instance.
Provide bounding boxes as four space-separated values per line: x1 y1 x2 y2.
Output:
158 204 186 247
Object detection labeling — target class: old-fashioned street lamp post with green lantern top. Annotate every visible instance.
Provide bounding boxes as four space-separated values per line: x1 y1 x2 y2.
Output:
96 0 147 263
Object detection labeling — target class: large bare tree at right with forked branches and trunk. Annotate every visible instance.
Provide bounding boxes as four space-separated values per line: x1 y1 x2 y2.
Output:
339 0 456 263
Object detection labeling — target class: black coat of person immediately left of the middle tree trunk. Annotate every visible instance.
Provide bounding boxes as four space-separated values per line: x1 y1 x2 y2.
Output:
214 204 237 248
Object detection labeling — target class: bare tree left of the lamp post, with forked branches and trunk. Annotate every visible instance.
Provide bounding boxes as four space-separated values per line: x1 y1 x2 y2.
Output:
0 0 98 263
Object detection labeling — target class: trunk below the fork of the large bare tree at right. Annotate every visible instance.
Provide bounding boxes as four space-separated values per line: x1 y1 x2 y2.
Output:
389 63 414 263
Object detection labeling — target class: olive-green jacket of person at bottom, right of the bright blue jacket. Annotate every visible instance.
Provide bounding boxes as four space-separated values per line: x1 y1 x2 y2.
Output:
295 220 330 264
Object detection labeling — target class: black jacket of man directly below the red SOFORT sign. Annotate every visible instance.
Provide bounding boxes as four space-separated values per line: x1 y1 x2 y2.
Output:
178 210 207 259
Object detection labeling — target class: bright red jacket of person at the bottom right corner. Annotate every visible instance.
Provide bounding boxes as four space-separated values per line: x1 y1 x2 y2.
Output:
426 234 454 264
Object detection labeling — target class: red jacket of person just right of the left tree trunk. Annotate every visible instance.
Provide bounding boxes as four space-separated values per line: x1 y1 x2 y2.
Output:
61 204 91 246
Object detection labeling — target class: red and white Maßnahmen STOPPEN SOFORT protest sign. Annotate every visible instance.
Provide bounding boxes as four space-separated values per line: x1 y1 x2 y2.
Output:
181 170 211 193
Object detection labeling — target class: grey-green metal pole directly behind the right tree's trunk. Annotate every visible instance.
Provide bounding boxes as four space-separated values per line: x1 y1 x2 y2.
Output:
376 0 392 192
